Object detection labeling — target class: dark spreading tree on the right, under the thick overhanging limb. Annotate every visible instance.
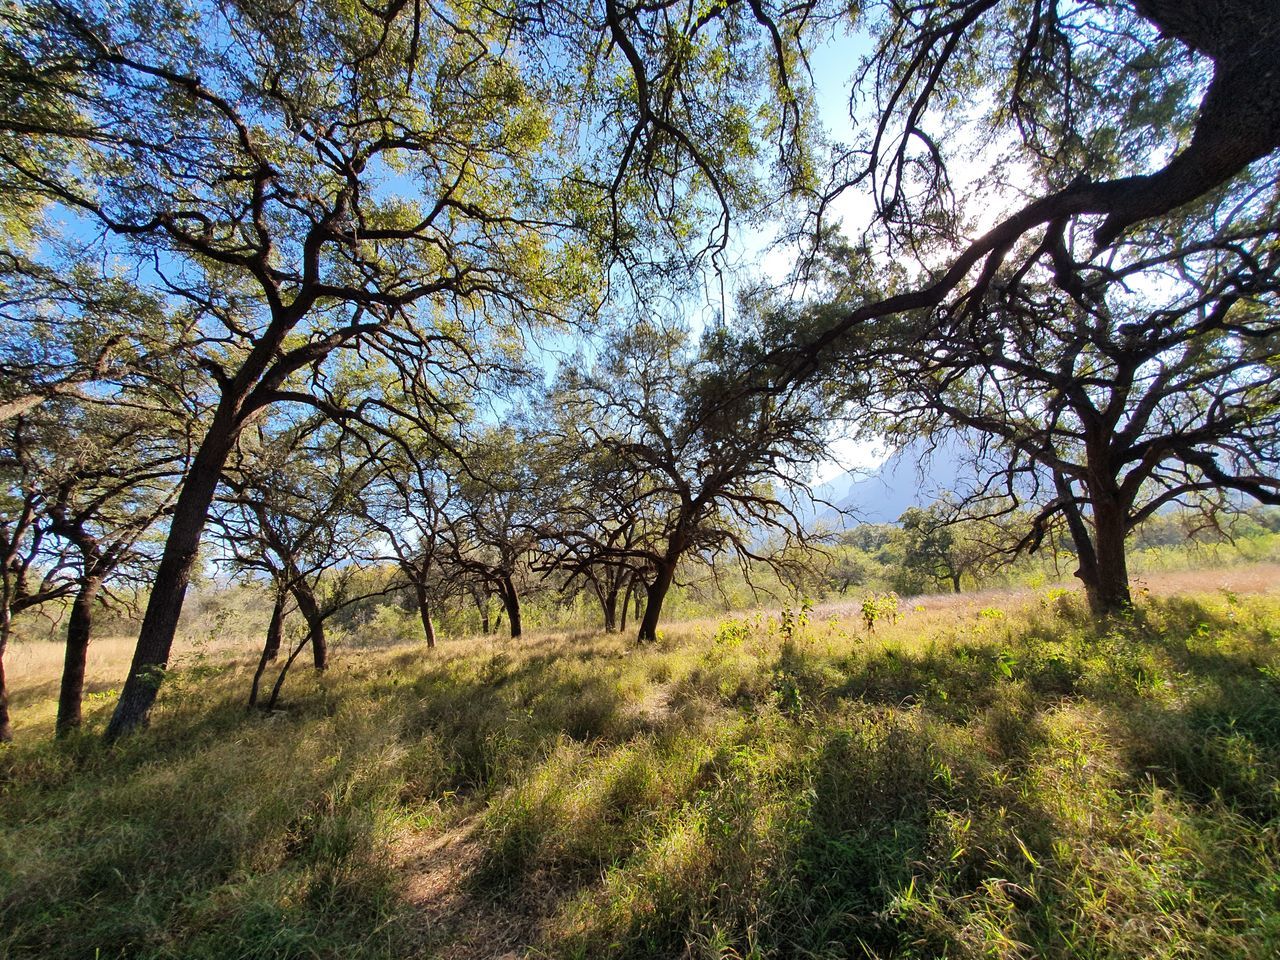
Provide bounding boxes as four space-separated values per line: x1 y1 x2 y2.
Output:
860 213 1280 614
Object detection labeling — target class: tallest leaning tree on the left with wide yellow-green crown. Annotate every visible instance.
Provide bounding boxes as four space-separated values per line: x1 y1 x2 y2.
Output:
0 3 599 737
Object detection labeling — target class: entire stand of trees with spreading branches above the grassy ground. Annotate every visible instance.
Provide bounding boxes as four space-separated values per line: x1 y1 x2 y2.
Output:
0 0 1280 739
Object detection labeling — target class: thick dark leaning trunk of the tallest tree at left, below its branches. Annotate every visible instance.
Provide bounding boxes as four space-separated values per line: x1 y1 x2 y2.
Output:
106 414 238 742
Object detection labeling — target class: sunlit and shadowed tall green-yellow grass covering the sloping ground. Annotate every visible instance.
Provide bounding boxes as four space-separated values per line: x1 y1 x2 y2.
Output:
0 572 1280 957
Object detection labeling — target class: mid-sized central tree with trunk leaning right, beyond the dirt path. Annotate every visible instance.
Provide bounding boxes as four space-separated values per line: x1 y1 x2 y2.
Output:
552 320 827 641
